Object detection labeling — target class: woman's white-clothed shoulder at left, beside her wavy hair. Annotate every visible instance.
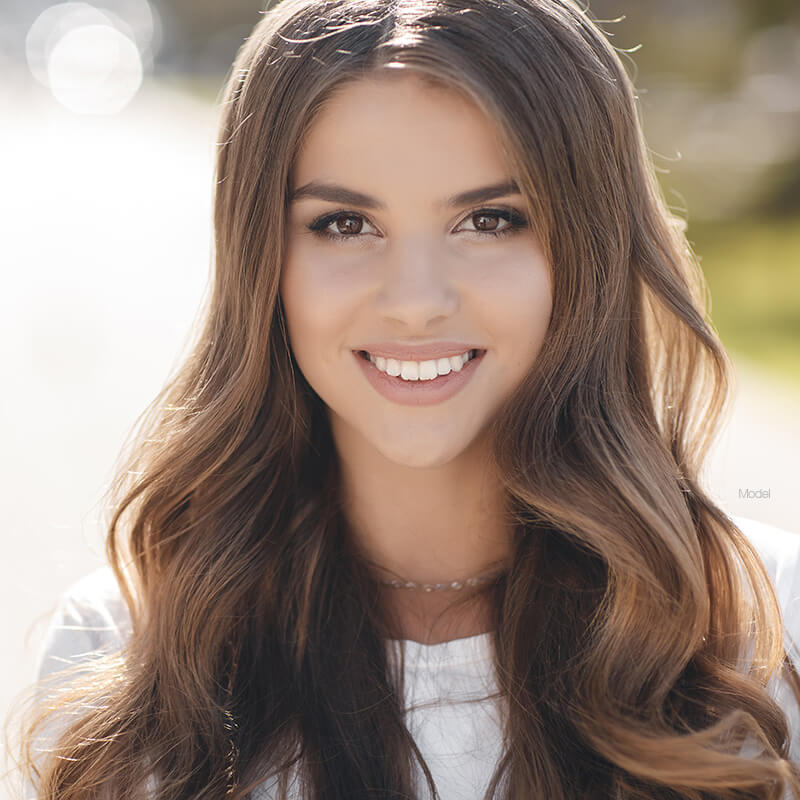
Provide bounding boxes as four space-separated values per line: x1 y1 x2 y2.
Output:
38 567 130 679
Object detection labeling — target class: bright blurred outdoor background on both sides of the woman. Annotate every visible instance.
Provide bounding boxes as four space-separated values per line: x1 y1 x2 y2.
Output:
0 0 800 792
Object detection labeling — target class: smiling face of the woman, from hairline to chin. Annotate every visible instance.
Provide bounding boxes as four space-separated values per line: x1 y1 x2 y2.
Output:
281 71 552 467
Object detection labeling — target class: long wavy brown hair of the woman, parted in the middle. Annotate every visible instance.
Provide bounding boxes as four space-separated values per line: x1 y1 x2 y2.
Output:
15 0 800 800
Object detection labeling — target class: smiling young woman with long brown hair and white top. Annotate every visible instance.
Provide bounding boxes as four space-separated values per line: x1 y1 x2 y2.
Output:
17 0 800 800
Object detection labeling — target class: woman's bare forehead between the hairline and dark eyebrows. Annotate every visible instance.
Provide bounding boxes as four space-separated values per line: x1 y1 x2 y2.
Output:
293 70 508 184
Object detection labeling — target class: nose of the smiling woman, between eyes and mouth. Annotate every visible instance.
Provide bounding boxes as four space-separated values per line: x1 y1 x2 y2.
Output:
375 244 459 332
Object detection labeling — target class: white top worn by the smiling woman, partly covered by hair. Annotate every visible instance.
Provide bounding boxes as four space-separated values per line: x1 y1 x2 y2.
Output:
32 516 800 800
